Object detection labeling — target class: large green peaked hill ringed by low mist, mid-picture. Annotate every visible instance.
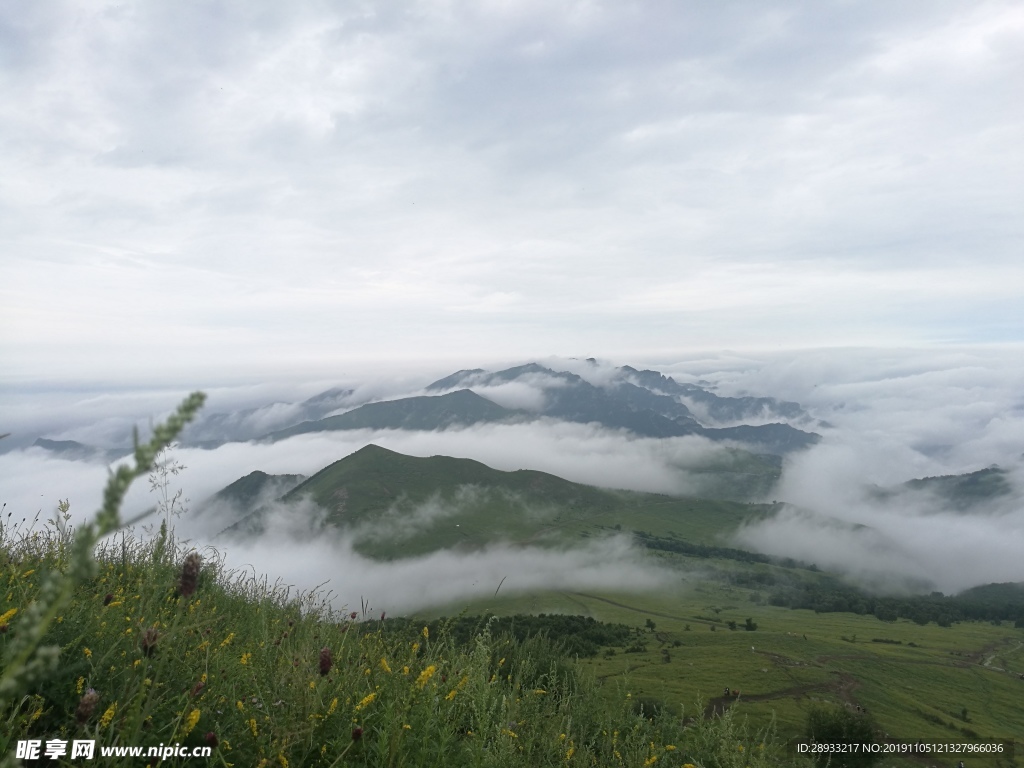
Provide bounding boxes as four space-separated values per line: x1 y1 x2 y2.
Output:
220 444 770 559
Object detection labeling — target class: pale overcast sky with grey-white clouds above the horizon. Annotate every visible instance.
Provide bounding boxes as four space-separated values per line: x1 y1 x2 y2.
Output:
0 0 1024 391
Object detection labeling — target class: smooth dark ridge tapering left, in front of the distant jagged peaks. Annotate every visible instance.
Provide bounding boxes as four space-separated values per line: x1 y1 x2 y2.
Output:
267 389 519 440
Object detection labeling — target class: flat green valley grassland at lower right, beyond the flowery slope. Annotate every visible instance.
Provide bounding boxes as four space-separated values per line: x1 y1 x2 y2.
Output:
415 577 1024 766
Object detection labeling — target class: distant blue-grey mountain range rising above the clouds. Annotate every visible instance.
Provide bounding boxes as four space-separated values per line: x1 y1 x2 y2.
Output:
267 362 820 455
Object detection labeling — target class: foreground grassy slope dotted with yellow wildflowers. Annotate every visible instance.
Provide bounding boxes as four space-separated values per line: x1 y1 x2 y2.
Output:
0 518 811 767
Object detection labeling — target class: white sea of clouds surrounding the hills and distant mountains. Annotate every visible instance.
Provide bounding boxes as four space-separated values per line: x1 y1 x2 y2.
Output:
0 347 1024 611
